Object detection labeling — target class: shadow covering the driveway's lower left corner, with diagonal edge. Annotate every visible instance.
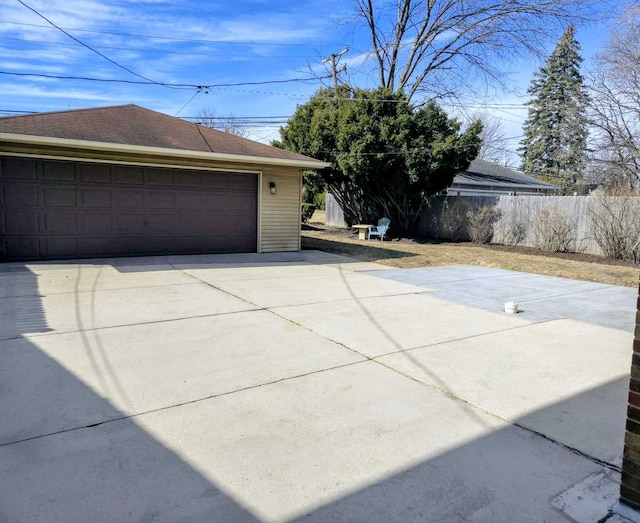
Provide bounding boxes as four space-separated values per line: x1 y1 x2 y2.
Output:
0 270 256 522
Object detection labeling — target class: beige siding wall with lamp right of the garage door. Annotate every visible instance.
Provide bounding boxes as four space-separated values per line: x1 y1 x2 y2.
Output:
260 167 302 252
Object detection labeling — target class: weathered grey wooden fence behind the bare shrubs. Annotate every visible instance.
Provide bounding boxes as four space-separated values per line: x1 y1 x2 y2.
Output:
325 194 640 254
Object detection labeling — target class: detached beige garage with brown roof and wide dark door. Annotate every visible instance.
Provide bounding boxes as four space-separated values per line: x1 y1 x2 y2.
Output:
0 105 327 260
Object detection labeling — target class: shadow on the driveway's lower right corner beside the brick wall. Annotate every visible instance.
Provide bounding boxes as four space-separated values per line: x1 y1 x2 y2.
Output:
295 378 628 523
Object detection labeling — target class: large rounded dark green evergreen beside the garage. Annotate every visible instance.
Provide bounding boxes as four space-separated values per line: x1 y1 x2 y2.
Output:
273 86 482 233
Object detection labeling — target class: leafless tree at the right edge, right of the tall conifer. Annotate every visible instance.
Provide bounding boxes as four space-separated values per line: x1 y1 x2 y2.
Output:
590 6 640 191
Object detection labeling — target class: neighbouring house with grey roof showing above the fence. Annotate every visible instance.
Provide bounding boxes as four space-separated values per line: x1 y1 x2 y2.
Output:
446 159 560 196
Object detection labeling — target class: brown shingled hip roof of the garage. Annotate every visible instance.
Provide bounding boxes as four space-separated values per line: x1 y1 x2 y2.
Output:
0 105 322 171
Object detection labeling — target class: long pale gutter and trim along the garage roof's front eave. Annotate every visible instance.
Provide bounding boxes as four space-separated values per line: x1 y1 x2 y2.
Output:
0 133 331 169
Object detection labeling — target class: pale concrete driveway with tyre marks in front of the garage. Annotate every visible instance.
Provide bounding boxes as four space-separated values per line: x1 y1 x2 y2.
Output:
0 251 635 522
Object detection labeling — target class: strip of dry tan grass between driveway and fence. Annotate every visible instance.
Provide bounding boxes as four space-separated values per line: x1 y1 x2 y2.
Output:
302 224 640 287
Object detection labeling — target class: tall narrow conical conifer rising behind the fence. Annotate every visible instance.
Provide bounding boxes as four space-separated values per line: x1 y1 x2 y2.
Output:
520 25 589 194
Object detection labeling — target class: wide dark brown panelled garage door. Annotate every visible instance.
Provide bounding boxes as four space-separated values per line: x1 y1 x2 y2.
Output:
0 158 258 260
